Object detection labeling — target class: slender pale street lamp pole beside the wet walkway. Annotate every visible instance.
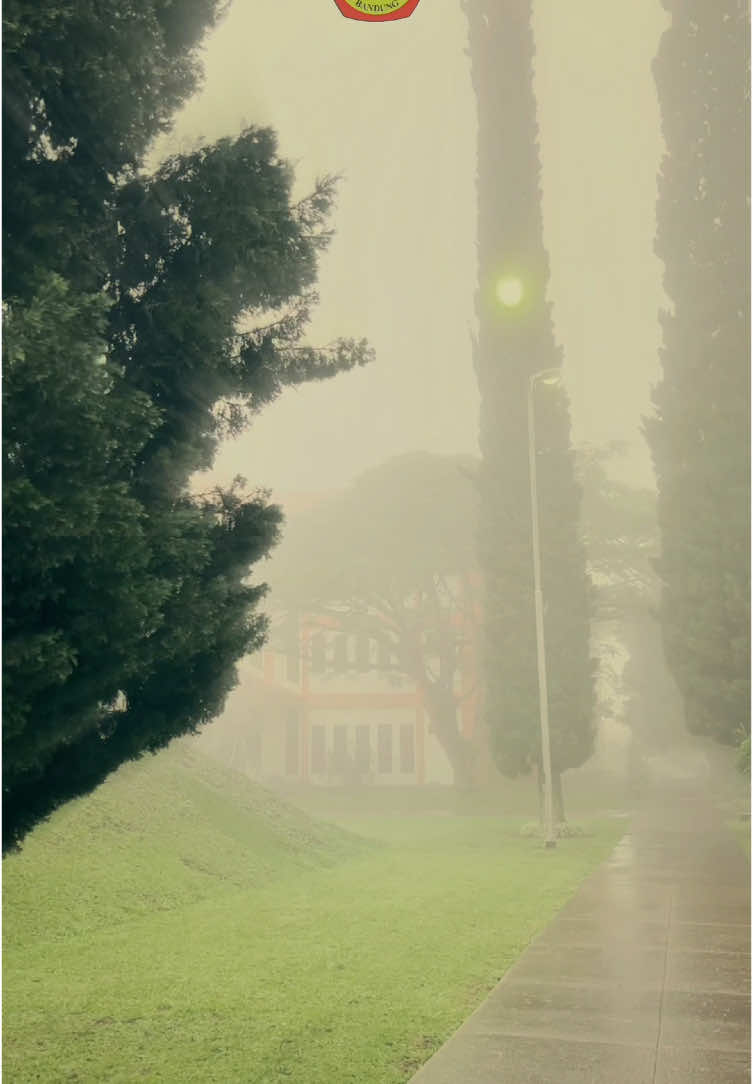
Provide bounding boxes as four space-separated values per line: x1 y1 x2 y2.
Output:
528 369 561 848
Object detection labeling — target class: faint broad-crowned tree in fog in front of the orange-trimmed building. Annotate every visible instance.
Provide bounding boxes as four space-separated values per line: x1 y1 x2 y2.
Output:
270 452 478 785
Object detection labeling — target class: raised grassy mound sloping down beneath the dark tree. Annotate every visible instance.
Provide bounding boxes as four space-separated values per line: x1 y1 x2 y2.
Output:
3 743 363 946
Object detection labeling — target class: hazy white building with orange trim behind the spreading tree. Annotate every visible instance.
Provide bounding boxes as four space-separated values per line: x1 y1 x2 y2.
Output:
202 602 477 786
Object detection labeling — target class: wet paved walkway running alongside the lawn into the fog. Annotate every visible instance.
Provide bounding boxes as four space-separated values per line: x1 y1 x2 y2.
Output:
413 784 751 1084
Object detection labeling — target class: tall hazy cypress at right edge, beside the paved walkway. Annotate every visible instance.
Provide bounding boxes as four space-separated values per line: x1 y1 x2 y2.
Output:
646 0 750 758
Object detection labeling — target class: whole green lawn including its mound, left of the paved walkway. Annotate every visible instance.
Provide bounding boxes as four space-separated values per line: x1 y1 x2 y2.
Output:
3 748 624 1084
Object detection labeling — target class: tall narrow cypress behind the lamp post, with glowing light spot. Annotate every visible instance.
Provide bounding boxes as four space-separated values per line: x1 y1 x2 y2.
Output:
465 0 594 814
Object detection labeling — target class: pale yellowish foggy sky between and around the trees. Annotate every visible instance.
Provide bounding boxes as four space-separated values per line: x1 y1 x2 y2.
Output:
154 0 666 493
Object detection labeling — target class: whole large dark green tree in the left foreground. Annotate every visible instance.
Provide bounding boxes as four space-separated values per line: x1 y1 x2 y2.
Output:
3 0 371 847
